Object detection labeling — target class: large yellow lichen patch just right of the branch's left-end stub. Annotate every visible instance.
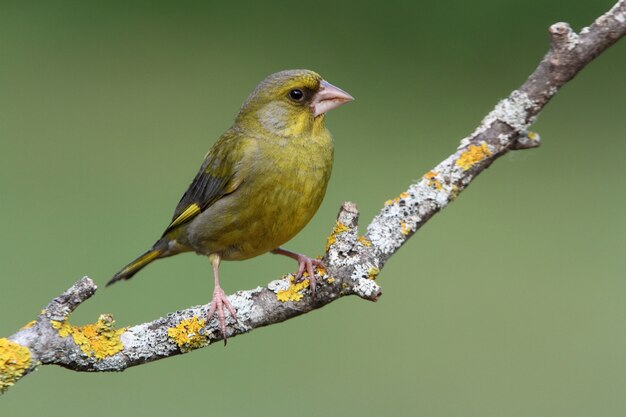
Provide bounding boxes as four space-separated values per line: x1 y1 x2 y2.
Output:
50 314 126 359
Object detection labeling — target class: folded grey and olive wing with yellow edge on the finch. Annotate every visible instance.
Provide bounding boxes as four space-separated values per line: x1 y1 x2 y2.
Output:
163 133 251 235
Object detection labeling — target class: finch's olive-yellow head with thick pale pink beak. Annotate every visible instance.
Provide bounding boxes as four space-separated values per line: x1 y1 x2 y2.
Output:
235 69 354 137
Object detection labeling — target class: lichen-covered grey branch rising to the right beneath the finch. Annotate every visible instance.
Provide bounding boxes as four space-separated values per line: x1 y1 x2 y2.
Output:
0 0 626 392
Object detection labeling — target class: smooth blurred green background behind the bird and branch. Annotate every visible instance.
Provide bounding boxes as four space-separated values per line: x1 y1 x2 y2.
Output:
0 0 626 417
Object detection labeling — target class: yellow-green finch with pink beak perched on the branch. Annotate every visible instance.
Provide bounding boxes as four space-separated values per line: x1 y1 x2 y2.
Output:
107 69 354 344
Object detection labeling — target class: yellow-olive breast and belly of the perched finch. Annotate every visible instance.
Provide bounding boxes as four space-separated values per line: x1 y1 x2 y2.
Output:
184 131 333 260
